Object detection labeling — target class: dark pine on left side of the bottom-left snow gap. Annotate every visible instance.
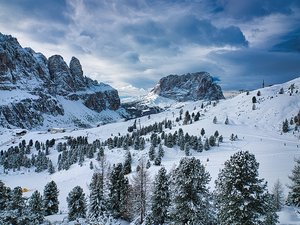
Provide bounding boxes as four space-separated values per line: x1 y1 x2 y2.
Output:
43 181 59 216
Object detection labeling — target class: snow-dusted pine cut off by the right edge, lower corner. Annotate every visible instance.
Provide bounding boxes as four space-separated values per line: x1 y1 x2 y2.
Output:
288 159 300 207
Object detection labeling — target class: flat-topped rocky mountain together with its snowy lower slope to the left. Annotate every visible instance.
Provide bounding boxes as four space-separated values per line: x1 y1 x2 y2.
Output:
122 72 224 118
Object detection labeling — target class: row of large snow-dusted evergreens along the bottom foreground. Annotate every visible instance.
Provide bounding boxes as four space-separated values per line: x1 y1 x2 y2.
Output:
0 151 280 225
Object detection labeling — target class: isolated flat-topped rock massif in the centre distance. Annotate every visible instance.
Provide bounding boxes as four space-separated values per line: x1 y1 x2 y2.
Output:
151 72 224 101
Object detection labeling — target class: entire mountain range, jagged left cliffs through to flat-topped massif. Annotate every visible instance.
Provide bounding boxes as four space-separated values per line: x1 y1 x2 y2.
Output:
0 33 224 129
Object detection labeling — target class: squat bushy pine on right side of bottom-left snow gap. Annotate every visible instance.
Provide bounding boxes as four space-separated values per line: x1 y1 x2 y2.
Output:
67 186 86 221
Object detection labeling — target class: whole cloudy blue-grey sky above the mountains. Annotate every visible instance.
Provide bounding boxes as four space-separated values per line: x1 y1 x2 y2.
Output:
0 0 300 96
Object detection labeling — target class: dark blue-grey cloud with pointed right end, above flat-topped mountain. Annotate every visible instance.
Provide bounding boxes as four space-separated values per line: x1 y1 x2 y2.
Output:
123 15 248 48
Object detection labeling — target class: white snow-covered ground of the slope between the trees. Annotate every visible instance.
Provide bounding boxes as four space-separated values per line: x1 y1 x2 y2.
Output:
0 78 300 224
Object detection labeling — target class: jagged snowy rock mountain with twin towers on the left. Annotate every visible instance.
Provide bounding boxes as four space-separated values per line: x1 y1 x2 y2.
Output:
0 33 120 129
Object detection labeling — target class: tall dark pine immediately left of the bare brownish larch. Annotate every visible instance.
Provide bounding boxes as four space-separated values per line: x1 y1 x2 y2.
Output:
108 163 129 219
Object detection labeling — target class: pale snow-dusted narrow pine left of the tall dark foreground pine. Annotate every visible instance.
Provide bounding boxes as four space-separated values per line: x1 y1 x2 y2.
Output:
88 173 106 221
